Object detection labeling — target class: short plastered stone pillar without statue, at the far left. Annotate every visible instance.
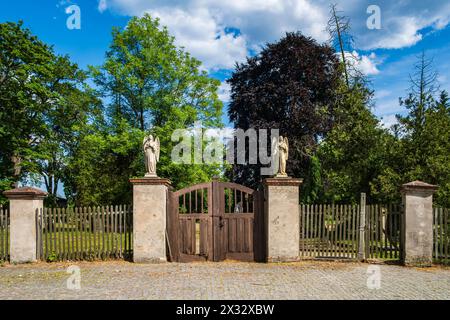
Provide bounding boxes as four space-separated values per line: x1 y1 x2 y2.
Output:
3 187 47 263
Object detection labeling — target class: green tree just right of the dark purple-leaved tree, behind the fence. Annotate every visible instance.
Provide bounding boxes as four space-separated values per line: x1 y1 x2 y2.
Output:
317 81 391 203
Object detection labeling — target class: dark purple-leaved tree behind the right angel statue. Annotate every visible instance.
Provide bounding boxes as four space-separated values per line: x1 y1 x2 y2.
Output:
228 33 339 187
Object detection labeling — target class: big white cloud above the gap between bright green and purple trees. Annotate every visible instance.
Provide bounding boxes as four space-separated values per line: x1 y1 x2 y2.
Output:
103 0 327 70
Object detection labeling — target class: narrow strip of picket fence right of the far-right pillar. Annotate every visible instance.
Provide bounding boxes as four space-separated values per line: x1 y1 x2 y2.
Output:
433 208 450 264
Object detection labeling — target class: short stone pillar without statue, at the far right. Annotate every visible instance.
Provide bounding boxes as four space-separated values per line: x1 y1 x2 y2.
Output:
402 181 437 267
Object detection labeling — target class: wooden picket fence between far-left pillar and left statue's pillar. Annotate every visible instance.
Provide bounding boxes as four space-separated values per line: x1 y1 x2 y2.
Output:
36 205 133 261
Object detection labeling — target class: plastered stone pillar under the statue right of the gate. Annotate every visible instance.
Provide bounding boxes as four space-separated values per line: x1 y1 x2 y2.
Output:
264 178 303 262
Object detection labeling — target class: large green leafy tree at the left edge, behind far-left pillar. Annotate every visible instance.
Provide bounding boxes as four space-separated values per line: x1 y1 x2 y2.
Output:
0 22 97 203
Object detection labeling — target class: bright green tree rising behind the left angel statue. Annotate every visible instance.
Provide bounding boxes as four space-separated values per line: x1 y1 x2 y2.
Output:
67 14 223 204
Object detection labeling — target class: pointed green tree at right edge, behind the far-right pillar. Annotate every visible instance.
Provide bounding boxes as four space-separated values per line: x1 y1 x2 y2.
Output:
372 53 450 207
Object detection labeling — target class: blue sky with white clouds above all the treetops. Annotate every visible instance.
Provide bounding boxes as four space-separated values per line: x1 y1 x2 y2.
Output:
0 0 450 129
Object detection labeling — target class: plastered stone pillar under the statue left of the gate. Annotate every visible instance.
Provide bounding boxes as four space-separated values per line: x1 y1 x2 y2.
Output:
130 177 170 263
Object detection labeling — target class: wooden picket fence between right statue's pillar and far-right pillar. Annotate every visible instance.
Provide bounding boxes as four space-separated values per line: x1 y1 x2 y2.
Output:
300 204 403 260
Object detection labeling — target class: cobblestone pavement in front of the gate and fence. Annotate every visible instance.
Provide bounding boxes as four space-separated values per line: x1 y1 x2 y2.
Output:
0 261 450 299
